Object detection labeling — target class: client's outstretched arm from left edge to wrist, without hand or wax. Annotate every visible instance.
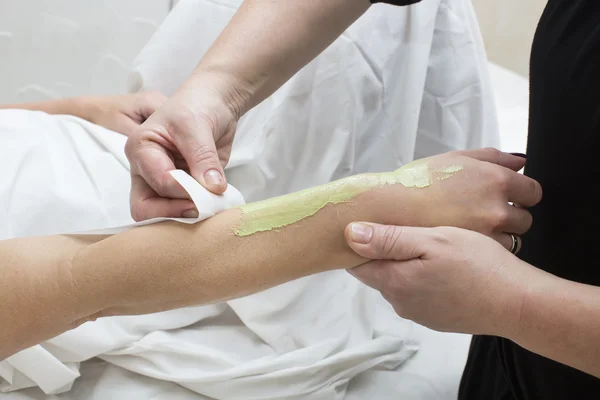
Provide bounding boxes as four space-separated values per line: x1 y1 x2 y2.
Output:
0 170 427 359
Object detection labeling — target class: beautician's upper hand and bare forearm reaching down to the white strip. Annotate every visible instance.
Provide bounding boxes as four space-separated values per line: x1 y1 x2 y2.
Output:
126 0 380 221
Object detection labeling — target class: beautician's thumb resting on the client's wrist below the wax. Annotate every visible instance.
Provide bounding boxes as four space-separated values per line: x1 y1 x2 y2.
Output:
345 222 426 261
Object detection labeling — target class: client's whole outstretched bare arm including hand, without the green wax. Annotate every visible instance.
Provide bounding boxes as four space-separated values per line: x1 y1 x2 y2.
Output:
0 149 541 359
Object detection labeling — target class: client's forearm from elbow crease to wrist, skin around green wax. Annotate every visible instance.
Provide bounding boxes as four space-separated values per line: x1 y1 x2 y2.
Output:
73 177 421 315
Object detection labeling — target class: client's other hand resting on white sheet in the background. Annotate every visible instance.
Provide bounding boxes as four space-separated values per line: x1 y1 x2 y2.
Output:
82 92 166 136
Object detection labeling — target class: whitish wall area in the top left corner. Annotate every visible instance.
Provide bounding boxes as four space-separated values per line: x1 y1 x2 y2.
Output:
0 0 171 103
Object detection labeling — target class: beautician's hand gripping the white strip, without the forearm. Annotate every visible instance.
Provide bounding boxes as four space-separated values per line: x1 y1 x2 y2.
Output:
125 77 240 221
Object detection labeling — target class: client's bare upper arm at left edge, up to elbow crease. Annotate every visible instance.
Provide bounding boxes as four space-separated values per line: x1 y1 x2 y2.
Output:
0 236 101 361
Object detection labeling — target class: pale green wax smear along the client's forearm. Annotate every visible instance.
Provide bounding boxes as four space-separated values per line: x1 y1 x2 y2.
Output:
234 159 462 236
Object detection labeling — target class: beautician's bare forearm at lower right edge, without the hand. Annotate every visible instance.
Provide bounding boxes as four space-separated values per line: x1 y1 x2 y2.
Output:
510 273 600 378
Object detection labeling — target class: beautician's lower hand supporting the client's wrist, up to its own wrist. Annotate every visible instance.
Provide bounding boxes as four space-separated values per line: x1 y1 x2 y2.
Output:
346 224 541 337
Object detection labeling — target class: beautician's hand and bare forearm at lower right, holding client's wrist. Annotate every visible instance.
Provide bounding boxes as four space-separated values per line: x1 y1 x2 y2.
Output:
347 224 600 378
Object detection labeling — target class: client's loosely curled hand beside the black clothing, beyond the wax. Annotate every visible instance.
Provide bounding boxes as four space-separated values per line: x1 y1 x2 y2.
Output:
405 149 542 242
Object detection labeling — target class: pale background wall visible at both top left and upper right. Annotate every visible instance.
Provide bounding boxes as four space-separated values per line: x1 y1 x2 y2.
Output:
0 0 546 103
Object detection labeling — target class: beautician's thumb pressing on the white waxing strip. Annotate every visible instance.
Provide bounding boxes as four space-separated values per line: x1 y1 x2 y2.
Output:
173 114 227 194
